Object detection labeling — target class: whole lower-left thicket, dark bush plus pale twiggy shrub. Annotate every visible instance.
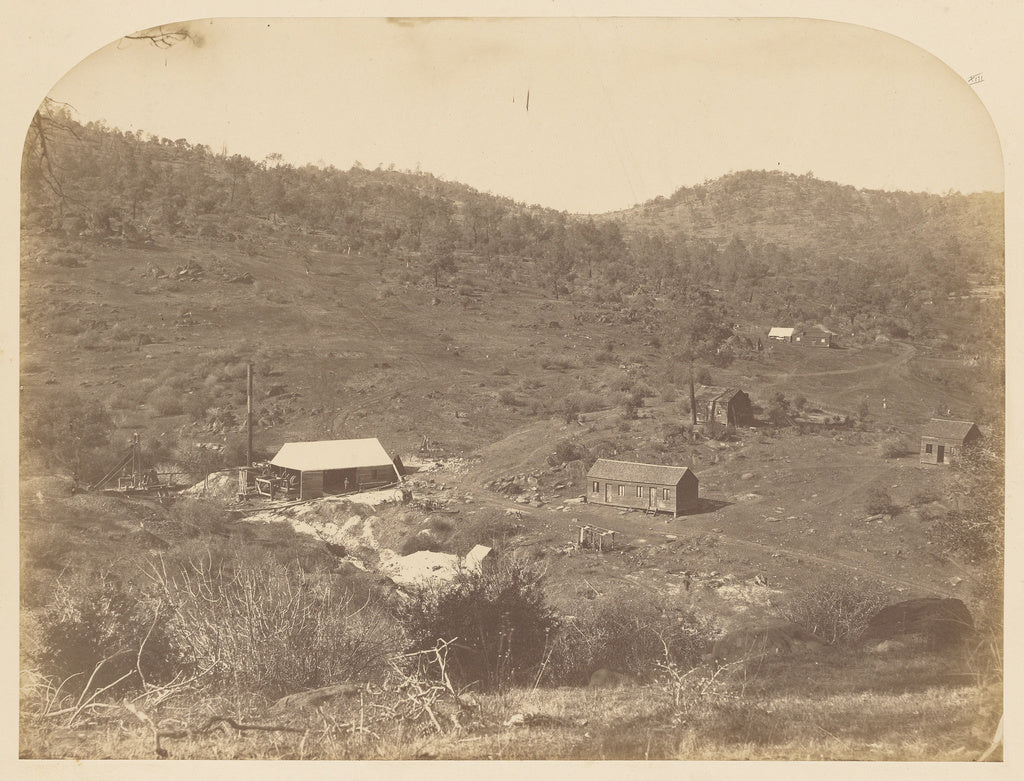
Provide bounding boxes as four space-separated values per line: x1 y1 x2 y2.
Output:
34 551 402 697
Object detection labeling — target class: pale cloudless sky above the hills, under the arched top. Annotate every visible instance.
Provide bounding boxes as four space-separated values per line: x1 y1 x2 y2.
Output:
50 18 1004 212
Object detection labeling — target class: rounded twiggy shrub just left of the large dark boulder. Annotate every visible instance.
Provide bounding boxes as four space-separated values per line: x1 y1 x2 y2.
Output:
776 579 887 645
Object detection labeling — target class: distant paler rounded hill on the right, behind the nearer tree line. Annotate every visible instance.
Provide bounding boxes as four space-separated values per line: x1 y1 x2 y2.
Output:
606 171 1004 278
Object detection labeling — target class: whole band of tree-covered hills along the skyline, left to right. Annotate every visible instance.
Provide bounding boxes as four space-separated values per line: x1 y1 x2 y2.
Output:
23 103 1004 335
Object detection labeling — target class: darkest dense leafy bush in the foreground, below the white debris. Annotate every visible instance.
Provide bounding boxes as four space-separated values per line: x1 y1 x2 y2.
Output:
399 559 557 688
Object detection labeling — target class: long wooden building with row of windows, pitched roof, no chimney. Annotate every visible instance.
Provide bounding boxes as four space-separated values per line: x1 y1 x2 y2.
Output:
587 459 698 515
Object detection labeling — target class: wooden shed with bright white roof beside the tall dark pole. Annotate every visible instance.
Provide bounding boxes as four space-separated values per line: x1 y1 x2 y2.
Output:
270 438 399 500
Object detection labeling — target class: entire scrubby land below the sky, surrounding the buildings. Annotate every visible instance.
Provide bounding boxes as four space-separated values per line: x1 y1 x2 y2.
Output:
19 115 1005 760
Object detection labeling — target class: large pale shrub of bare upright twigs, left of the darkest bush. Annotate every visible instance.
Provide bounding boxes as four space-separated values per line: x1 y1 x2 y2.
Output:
153 557 400 697
